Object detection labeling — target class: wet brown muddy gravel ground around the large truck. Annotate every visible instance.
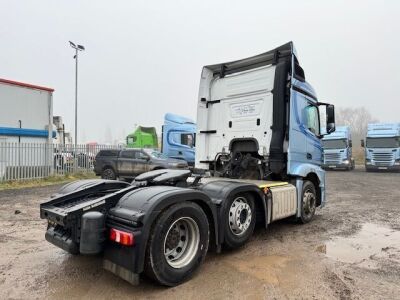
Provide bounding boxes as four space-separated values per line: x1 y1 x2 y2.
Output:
0 168 400 299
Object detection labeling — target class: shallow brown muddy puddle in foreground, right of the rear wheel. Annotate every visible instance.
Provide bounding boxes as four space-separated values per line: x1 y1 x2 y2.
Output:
228 255 289 284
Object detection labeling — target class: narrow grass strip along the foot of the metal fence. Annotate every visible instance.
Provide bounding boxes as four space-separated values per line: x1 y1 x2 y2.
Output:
0 172 98 191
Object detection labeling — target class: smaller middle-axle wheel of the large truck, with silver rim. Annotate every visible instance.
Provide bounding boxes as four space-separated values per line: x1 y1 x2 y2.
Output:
224 194 256 249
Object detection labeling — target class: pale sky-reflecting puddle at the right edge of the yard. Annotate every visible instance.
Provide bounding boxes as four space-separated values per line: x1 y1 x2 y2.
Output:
316 223 400 268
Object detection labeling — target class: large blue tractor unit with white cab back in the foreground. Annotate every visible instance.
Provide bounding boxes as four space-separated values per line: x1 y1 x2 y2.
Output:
40 42 335 286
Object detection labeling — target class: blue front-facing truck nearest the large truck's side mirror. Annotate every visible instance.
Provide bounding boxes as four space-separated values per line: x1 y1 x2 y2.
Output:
322 126 355 170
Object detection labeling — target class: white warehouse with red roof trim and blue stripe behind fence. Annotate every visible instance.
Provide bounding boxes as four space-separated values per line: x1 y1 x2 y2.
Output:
0 79 56 181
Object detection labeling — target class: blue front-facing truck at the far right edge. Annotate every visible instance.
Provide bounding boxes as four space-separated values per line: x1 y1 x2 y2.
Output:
361 123 400 171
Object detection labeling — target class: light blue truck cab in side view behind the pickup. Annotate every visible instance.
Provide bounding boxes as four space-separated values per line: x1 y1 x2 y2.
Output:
161 113 196 166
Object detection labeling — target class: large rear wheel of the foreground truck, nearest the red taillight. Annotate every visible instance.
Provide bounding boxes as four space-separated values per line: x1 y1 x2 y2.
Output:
145 202 210 286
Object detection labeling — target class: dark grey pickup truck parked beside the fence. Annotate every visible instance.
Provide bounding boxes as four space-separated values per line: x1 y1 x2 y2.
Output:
94 149 188 180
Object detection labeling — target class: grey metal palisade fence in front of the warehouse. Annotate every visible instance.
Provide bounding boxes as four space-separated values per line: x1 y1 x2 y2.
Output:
0 142 119 182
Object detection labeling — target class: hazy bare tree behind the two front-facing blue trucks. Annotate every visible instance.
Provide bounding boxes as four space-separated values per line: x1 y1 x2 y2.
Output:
336 107 378 144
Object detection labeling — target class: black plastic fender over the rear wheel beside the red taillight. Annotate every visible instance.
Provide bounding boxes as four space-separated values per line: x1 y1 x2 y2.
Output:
108 186 219 273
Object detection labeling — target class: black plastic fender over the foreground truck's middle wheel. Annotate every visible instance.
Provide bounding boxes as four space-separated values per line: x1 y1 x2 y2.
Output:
199 179 268 245
